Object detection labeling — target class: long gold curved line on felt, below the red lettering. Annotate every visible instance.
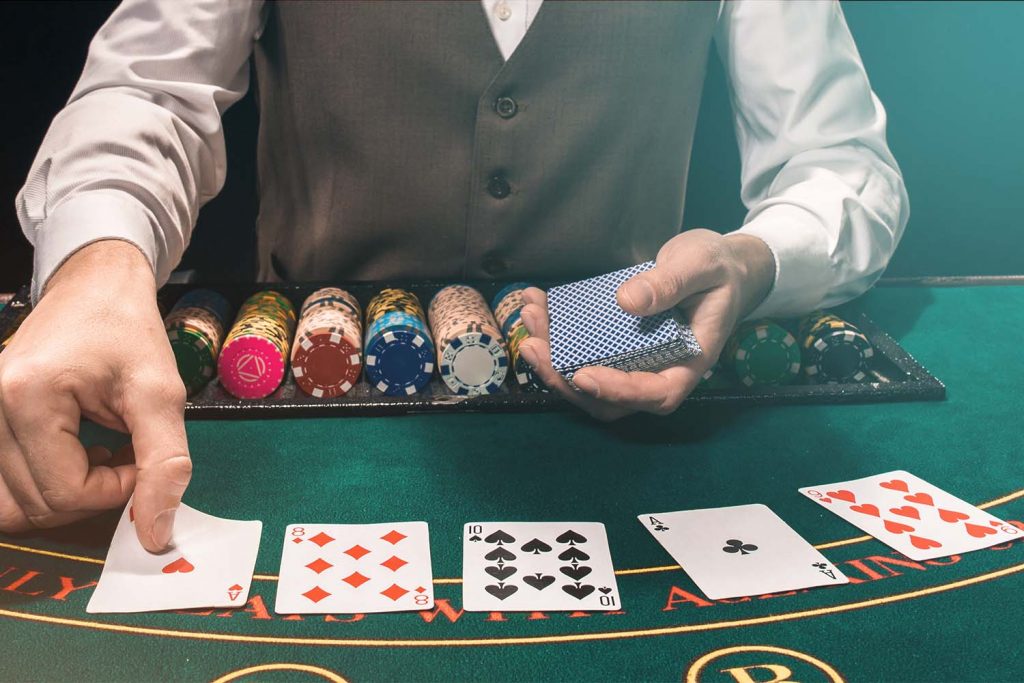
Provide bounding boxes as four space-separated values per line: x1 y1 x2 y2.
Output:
0 563 1024 647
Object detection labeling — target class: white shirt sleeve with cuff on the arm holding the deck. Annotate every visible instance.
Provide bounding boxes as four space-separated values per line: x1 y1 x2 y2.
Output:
715 0 909 317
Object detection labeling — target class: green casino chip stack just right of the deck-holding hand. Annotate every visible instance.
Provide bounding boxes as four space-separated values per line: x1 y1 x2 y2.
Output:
721 319 801 387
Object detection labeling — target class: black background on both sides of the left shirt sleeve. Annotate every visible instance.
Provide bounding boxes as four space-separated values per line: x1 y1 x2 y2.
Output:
0 0 257 292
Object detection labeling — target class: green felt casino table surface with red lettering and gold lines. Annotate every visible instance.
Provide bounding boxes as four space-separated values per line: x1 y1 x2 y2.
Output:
0 287 1024 683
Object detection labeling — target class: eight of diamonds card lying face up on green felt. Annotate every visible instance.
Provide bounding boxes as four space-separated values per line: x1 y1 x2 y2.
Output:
274 521 434 614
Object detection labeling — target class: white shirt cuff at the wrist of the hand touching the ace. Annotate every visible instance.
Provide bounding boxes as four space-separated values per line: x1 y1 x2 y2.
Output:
32 190 158 304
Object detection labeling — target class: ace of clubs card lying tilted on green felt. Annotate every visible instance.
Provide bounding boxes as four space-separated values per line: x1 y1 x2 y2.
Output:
639 505 849 600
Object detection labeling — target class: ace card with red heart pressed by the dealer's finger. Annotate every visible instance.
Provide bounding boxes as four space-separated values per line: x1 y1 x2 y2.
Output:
86 501 263 614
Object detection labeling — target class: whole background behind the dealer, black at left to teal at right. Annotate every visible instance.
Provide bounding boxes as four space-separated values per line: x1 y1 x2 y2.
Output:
0 0 1024 291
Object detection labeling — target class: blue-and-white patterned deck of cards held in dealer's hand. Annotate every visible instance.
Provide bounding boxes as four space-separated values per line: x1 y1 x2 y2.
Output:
548 261 700 381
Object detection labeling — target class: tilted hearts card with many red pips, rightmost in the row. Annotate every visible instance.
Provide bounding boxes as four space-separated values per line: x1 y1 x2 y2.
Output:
800 470 1021 560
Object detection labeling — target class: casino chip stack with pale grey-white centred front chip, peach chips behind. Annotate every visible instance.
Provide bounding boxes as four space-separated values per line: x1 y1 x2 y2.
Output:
429 285 509 396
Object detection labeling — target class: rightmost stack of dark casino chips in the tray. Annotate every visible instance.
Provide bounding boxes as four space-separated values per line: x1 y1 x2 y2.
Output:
800 311 874 384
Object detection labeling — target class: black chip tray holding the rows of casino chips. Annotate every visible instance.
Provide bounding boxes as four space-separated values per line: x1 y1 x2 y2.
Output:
0 283 946 420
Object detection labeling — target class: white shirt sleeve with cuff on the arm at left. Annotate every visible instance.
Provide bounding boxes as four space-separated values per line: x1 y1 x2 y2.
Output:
15 0 263 300
